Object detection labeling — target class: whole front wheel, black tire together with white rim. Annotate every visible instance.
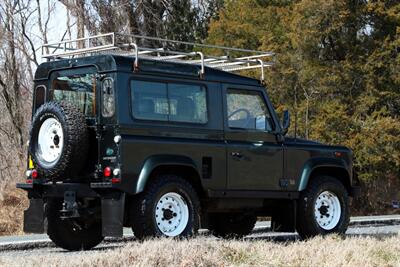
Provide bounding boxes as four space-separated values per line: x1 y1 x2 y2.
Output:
297 176 350 238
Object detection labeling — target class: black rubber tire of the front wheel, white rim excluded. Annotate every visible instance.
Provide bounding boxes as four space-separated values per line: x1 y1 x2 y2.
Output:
296 176 350 239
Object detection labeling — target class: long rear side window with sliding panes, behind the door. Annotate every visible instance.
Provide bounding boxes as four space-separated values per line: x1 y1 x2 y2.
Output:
131 80 207 123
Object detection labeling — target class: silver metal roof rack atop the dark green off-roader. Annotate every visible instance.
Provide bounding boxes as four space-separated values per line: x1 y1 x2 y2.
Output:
42 32 275 82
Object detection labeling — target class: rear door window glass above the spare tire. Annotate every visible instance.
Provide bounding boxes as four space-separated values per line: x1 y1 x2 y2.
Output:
51 68 96 117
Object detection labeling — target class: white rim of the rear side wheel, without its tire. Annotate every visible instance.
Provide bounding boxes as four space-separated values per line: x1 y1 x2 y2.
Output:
154 192 189 236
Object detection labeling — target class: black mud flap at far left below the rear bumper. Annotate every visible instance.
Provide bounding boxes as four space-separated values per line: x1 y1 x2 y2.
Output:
24 198 44 234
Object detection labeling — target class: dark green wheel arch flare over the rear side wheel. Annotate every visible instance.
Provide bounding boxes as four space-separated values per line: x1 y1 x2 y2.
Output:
135 155 204 196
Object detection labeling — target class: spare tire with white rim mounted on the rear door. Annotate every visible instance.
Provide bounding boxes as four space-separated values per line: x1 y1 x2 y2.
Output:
29 101 89 180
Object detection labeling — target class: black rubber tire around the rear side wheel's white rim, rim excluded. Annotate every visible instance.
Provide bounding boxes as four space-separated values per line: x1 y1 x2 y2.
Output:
130 175 201 240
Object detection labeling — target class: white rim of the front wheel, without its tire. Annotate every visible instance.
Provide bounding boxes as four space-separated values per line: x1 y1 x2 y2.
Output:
314 191 342 230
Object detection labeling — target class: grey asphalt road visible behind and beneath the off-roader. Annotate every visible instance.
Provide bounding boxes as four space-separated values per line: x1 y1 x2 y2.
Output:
0 215 400 257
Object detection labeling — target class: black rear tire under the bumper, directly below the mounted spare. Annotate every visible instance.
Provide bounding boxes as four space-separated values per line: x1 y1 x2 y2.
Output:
46 199 103 251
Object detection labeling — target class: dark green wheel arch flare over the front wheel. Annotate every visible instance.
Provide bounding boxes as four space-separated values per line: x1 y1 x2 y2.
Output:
298 158 352 194
